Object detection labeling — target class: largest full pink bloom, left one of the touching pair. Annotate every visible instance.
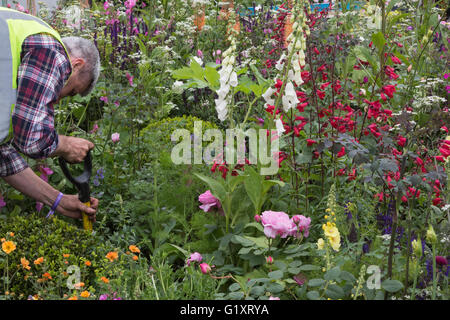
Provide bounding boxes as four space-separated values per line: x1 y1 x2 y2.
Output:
261 211 297 238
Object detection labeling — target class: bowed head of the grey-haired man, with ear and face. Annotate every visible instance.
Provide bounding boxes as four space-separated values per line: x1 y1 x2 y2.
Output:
59 37 100 99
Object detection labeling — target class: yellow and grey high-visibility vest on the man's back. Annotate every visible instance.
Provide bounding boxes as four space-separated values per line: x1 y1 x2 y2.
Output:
0 7 69 143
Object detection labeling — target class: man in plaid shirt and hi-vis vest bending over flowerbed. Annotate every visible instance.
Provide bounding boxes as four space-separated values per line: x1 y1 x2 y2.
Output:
0 7 100 222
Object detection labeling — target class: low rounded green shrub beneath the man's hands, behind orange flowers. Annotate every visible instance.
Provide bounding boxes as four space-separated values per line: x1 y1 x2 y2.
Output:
0 213 101 299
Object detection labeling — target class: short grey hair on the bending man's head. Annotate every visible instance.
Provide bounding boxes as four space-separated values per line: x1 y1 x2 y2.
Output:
61 37 100 97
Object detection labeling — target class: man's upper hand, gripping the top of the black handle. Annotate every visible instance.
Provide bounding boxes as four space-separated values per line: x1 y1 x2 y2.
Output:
51 135 94 163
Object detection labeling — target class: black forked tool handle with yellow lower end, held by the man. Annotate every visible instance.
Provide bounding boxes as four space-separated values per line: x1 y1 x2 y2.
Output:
58 151 92 231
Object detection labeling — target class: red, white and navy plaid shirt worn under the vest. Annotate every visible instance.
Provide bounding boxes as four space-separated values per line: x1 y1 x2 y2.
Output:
0 34 72 177
